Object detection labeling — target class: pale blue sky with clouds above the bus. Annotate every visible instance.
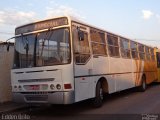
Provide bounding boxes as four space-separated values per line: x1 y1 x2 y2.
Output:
0 0 160 47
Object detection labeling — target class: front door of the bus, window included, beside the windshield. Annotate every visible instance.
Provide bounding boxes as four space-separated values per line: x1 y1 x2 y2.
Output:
72 25 93 102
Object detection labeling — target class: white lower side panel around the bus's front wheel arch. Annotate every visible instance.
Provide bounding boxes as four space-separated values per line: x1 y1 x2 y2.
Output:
75 75 116 102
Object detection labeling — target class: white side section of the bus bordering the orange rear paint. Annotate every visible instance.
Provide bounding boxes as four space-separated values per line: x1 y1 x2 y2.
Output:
109 57 135 91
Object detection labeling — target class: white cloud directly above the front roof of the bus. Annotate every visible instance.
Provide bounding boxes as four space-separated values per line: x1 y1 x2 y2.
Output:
46 5 85 20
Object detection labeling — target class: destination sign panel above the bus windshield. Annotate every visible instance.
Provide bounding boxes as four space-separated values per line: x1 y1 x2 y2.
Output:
15 17 68 35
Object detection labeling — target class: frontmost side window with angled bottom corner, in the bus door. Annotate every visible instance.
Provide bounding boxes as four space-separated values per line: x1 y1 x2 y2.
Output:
72 26 90 64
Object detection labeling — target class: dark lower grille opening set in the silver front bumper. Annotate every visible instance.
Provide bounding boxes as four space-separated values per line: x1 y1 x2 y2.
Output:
25 95 48 101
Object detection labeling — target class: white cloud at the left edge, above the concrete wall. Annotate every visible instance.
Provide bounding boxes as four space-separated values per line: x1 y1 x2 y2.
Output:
0 9 36 26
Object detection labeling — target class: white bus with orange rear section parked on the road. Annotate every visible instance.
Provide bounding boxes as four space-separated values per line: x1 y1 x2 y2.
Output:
11 17 157 107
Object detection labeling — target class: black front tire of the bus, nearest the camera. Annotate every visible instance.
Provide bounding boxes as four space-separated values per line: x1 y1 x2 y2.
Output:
93 81 104 108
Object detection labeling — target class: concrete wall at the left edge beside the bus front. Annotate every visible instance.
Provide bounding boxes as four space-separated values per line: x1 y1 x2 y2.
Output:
0 45 14 103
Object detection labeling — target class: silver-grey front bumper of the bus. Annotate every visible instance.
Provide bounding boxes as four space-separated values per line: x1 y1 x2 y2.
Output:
13 91 75 104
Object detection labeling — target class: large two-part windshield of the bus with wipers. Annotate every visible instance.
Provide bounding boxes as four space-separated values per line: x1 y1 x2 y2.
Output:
13 28 71 69
